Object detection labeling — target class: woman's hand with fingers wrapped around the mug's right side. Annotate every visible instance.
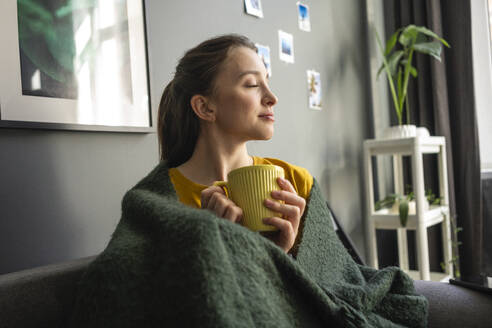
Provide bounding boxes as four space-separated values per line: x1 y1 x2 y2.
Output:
263 178 306 252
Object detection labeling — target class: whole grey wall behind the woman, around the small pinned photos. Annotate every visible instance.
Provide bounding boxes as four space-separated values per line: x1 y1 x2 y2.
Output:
0 0 370 273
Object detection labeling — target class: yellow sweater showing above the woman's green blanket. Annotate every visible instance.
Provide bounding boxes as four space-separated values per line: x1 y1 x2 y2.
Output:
169 156 313 208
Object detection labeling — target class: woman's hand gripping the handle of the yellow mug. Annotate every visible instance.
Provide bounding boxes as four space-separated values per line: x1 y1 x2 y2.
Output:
200 186 243 222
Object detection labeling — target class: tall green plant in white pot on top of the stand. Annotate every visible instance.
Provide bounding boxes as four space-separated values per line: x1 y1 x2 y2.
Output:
376 25 449 138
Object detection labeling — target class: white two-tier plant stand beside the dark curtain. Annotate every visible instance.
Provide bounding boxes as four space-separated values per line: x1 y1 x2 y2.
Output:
364 137 453 281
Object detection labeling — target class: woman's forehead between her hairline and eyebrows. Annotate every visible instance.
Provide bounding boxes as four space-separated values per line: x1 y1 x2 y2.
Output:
222 47 266 78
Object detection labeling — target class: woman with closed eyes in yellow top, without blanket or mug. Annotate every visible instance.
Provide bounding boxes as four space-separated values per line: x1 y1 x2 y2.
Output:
158 35 312 252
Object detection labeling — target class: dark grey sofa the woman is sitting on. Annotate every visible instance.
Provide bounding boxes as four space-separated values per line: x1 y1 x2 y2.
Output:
0 257 492 328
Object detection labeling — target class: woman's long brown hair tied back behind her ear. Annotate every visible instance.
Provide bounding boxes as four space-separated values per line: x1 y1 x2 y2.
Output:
157 34 257 167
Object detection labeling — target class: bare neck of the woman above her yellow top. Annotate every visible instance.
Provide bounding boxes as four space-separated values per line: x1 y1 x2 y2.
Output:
177 129 253 186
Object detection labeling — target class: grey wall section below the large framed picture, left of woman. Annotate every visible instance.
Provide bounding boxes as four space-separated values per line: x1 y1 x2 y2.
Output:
0 129 158 273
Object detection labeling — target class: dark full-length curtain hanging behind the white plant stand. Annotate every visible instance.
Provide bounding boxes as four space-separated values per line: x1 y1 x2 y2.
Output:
381 0 483 283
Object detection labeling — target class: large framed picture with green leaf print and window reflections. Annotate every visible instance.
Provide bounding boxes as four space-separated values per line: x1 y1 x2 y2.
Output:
0 0 153 132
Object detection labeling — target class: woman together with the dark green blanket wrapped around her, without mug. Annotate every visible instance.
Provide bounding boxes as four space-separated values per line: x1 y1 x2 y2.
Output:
70 35 427 328
